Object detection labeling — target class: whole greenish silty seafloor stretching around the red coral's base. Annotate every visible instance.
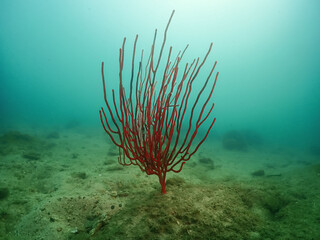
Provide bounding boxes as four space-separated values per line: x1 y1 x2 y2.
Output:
0 124 320 240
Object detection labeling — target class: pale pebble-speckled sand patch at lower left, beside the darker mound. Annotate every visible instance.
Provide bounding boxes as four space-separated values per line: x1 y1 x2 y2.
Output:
12 194 123 240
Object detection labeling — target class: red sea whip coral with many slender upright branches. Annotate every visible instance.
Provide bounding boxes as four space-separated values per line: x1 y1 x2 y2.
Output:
99 11 219 194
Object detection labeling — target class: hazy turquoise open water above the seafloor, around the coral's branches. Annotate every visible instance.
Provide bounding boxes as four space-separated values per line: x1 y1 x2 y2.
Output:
0 1 320 146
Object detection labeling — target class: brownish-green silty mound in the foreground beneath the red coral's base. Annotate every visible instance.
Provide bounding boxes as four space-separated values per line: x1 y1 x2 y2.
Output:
84 177 320 240
